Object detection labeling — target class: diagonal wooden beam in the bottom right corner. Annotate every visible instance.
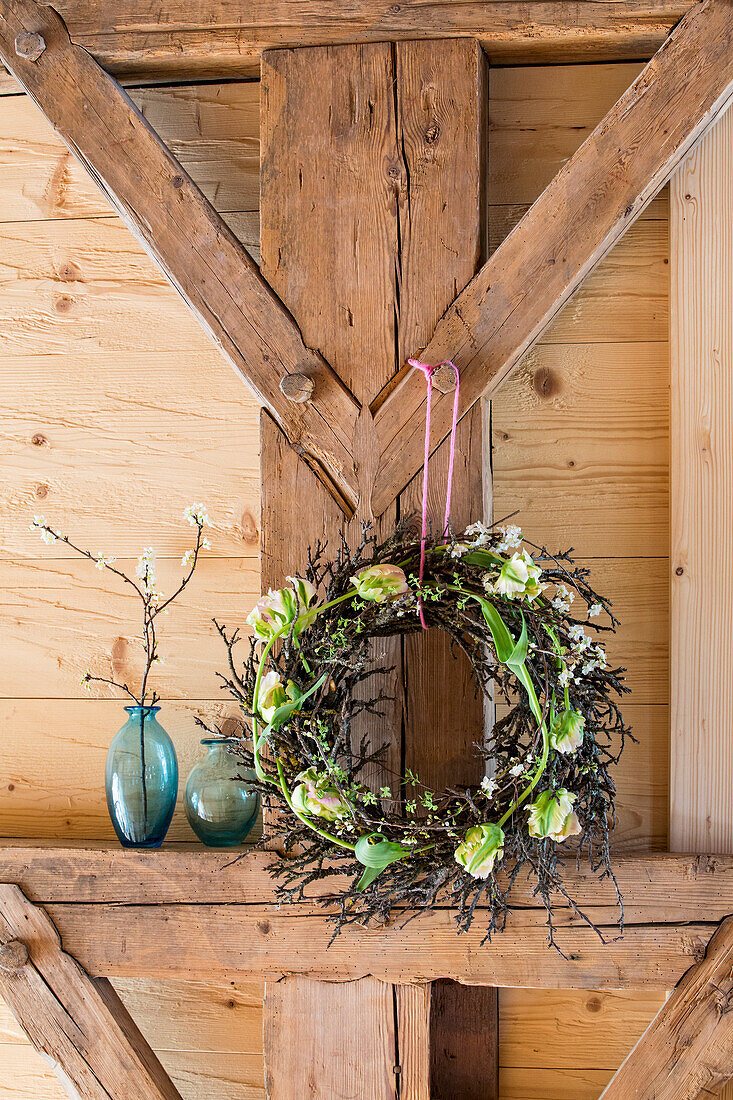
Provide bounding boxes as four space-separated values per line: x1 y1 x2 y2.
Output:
601 917 733 1100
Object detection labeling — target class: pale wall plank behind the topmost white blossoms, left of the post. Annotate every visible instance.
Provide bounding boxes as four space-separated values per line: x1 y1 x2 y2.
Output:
0 347 260 564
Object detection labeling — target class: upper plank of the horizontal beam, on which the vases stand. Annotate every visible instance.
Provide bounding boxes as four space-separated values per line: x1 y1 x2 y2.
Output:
7 839 733 924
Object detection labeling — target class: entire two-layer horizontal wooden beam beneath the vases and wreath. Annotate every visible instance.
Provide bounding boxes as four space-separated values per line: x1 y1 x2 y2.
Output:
0 842 733 989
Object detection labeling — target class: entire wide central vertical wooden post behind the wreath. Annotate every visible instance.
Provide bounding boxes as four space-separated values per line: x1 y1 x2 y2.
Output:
256 41 486 1100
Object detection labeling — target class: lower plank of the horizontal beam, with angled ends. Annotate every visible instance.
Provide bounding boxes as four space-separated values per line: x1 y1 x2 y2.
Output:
27 902 714 990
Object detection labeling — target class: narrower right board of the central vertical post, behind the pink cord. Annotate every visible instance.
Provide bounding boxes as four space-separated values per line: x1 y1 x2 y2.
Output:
396 41 491 790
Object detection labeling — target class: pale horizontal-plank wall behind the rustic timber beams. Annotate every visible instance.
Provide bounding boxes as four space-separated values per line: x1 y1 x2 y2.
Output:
0 64 668 1100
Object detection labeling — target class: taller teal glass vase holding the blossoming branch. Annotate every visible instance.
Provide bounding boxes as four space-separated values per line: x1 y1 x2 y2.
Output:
106 706 178 848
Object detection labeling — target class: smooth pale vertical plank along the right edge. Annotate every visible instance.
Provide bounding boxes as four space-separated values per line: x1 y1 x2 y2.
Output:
670 105 733 851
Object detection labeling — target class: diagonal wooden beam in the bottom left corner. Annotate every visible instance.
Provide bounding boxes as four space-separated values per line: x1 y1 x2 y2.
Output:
0 886 180 1100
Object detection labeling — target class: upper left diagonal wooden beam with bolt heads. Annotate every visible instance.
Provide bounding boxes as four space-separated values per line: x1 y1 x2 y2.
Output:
0 0 359 513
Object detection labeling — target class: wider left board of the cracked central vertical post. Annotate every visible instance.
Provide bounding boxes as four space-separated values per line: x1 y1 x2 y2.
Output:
261 45 401 1100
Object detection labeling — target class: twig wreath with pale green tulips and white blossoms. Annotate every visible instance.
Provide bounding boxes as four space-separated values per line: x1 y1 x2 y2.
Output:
211 524 631 946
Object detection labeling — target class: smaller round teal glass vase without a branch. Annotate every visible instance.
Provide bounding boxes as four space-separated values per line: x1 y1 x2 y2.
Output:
186 737 260 848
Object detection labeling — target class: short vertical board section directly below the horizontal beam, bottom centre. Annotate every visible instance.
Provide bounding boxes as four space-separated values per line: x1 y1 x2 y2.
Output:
264 978 396 1100
